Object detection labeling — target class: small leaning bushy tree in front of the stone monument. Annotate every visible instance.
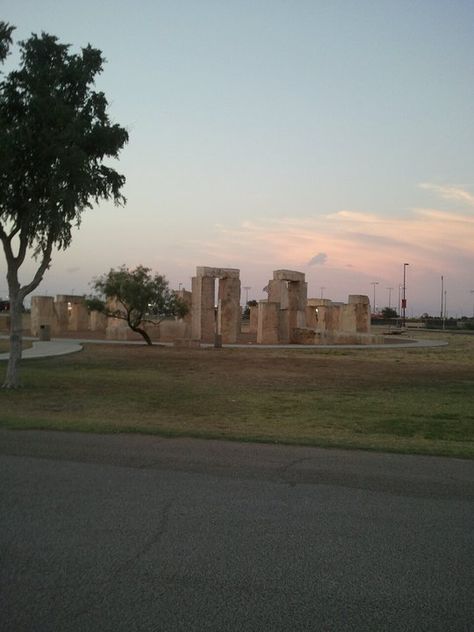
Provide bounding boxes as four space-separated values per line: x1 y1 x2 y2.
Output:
89 266 189 345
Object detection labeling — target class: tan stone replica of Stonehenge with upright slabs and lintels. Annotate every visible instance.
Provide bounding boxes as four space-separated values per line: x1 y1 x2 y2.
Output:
31 266 383 346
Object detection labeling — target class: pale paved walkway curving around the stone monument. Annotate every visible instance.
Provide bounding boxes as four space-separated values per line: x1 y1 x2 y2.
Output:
0 336 448 361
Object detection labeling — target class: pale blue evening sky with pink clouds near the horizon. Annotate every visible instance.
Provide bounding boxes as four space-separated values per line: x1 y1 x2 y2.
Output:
0 0 474 316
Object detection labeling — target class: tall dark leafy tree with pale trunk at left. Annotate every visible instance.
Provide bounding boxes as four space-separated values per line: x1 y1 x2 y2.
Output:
0 22 128 388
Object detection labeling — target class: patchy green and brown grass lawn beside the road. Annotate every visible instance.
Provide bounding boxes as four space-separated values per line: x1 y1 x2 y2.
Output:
0 333 474 458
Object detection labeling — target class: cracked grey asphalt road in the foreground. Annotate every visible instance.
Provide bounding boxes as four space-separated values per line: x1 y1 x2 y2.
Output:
0 431 474 632
